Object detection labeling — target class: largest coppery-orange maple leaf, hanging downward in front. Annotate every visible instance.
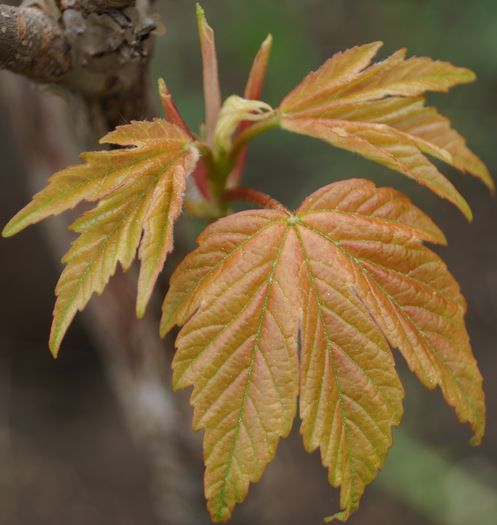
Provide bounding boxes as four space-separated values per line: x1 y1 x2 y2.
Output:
161 179 485 521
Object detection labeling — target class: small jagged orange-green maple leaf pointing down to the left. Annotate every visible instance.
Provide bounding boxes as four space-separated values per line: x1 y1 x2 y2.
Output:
3 119 198 355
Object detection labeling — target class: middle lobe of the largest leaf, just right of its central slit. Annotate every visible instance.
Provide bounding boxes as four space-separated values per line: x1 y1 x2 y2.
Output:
298 223 403 520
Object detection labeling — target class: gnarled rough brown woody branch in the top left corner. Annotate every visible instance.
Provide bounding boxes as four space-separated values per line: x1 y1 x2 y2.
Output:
0 0 157 97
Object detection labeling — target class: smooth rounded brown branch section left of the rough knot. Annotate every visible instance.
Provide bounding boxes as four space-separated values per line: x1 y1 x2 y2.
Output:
0 5 70 82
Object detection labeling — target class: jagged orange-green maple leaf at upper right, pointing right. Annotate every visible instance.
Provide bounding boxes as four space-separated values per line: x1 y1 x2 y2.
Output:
280 42 494 219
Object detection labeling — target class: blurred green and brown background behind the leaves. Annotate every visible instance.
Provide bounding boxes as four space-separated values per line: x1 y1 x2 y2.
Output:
0 0 497 525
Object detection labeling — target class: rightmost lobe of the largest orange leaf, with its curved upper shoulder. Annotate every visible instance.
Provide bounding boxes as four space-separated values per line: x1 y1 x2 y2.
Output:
299 180 485 442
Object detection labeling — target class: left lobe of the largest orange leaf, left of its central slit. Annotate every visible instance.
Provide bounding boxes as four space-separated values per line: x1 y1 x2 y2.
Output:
168 212 300 521
